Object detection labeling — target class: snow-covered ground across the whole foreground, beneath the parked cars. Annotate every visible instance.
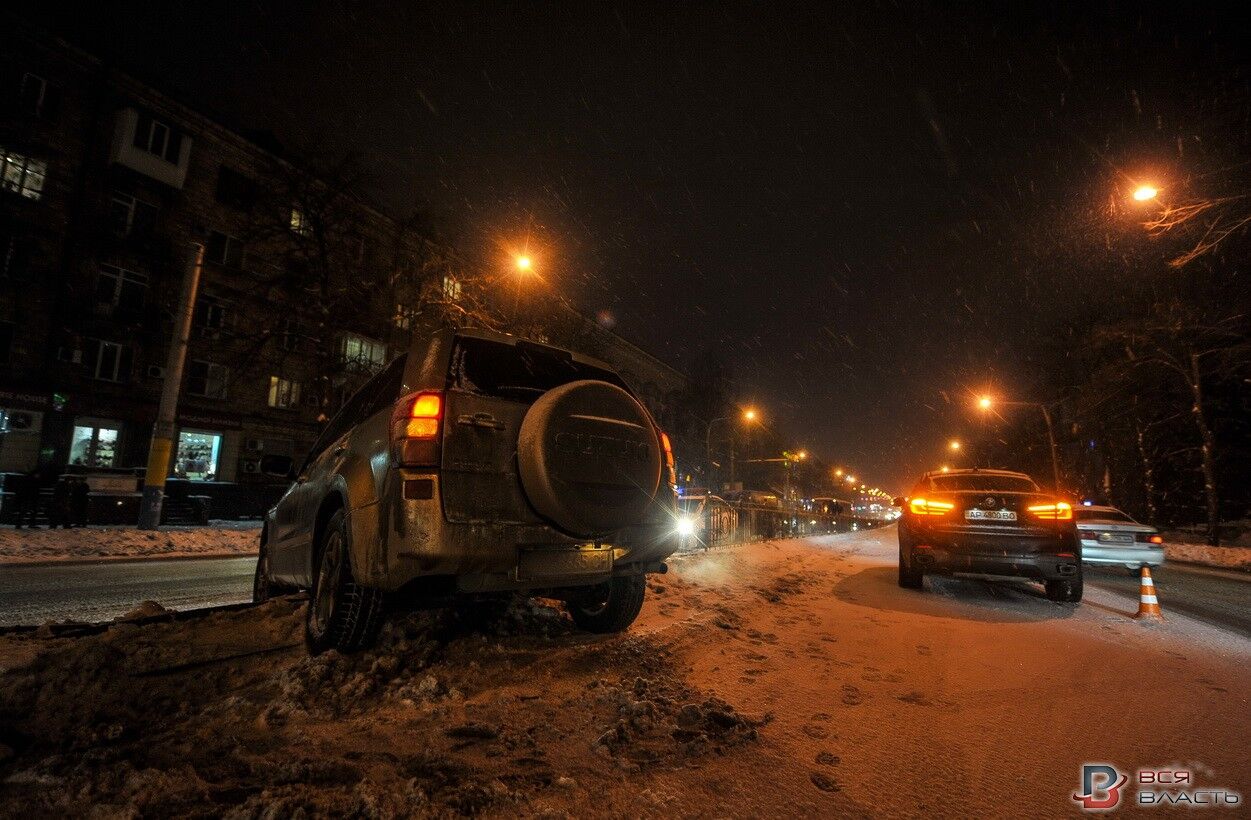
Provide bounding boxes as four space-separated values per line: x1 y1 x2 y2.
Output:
0 528 1251 817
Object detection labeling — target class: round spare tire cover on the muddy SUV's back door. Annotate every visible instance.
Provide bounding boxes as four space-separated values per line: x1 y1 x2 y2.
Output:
517 381 662 536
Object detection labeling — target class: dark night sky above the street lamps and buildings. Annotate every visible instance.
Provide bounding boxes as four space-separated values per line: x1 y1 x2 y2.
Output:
22 1 1251 488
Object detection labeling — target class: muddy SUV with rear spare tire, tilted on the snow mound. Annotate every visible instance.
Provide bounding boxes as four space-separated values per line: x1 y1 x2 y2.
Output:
253 331 677 652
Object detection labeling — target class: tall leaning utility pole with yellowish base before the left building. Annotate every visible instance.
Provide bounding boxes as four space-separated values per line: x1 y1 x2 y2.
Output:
139 243 204 530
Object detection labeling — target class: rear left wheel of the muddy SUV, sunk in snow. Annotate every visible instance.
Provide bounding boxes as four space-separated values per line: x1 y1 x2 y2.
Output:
304 510 383 655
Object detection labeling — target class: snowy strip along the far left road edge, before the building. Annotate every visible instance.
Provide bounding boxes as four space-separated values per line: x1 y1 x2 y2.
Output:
0 522 260 565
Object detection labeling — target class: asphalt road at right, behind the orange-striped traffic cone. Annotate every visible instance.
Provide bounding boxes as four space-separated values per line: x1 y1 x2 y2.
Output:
1085 563 1251 637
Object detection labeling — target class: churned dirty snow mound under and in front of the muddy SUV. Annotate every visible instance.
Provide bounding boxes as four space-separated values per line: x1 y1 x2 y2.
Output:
0 590 763 817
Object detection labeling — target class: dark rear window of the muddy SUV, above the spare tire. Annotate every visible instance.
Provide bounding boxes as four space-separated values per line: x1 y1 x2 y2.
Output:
448 338 626 402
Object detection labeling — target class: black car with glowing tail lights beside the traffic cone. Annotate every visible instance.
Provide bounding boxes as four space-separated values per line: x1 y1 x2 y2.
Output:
896 468 1082 602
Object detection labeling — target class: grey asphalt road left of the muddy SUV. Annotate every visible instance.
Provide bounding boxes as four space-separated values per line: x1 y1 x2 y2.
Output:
0 556 256 626
